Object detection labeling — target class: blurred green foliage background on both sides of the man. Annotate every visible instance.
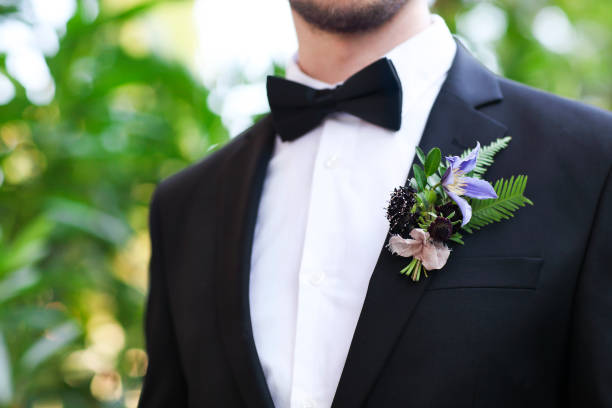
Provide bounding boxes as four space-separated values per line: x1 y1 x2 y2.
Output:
0 0 612 408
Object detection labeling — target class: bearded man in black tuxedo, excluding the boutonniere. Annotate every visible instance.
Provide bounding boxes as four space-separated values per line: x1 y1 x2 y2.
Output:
140 0 612 408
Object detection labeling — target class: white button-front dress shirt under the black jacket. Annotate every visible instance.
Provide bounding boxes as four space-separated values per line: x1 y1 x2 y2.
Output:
249 15 456 408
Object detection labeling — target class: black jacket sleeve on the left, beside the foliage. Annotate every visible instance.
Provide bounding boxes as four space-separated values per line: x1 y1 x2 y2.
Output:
138 190 187 408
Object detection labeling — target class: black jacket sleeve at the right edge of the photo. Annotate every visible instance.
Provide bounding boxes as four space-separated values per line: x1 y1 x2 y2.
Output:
569 165 612 408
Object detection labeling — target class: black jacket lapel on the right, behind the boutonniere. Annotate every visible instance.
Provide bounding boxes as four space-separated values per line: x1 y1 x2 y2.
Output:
332 44 506 407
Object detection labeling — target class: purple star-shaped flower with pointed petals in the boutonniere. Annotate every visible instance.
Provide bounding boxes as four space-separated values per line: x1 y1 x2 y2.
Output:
441 142 497 227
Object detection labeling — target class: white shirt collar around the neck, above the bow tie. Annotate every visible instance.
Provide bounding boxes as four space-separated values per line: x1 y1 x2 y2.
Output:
285 14 457 115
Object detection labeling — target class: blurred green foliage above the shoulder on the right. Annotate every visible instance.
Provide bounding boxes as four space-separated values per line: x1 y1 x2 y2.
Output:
435 0 612 110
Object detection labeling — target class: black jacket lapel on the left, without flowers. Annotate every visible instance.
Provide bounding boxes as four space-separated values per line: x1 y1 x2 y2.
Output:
215 116 275 408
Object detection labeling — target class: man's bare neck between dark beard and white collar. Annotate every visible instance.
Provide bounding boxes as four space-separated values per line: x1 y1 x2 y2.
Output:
292 0 431 84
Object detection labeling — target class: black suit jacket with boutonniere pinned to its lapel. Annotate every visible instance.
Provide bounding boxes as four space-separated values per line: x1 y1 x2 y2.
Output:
140 43 612 408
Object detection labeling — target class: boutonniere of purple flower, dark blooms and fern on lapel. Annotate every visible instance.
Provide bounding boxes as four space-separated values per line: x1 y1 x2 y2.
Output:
387 136 533 282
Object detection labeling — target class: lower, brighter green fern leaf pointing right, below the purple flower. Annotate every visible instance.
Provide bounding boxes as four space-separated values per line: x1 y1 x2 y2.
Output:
463 175 533 233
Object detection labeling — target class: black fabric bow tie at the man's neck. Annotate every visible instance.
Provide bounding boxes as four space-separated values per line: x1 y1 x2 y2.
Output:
267 58 402 141
